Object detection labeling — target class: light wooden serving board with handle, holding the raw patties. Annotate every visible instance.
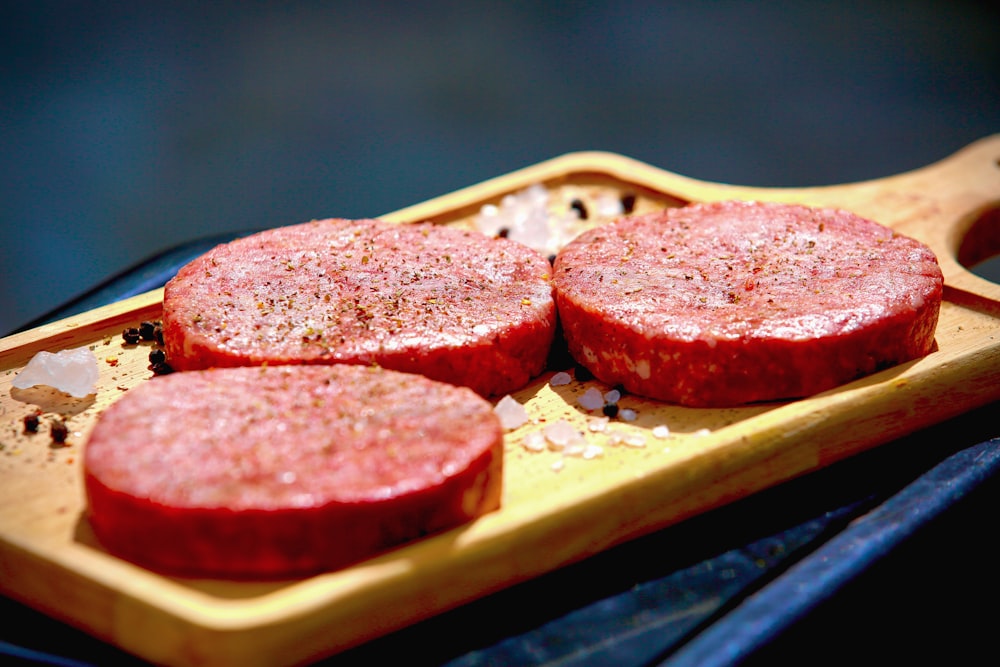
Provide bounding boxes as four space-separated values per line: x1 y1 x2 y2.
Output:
0 135 1000 666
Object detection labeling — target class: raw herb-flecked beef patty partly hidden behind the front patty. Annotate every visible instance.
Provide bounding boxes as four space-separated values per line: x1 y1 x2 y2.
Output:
163 220 556 396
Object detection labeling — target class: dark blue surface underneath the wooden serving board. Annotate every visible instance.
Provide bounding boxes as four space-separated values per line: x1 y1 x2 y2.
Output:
7 248 1000 667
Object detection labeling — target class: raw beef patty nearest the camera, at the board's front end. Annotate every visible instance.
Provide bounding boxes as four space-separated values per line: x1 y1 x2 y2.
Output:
84 365 503 578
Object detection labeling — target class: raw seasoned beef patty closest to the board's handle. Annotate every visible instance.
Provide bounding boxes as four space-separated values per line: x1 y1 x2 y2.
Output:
553 201 943 407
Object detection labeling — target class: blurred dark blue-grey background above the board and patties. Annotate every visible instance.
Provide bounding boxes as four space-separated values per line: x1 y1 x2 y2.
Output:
0 0 1000 335
